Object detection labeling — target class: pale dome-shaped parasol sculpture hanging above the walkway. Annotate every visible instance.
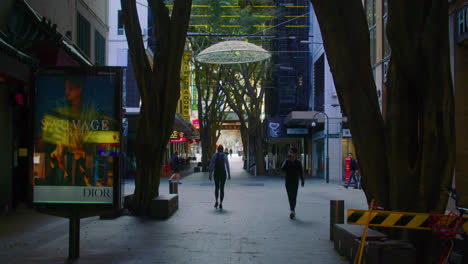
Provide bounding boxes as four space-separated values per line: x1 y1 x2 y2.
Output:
196 40 271 64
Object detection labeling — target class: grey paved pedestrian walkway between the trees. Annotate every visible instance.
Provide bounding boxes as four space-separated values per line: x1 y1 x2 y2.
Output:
0 157 366 264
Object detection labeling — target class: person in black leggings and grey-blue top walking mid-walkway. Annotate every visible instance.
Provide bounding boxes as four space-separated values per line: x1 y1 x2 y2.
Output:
209 145 231 209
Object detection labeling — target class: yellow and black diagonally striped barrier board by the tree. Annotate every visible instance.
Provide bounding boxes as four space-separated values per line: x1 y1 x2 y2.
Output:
347 209 468 232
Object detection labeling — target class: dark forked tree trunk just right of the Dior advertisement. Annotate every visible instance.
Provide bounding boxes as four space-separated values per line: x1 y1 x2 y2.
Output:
121 0 192 215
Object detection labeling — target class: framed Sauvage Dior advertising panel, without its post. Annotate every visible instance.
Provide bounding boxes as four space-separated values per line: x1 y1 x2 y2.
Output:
33 67 122 205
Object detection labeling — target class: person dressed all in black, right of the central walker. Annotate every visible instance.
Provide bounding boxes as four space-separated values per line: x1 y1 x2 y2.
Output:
281 147 304 219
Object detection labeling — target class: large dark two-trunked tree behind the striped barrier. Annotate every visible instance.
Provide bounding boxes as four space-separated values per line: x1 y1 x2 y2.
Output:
311 0 455 263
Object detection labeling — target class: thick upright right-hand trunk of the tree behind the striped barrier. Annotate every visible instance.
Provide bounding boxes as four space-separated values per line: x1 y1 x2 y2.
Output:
386 0 455 213
